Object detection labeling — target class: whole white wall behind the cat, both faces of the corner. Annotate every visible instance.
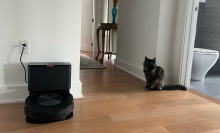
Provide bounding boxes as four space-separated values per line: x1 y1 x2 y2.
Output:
115 0 178 83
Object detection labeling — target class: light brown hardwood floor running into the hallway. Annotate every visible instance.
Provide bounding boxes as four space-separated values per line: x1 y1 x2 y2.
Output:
0 52 220 133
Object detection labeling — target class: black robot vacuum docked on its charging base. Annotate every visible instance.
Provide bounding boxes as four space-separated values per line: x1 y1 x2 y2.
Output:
24 62 74 123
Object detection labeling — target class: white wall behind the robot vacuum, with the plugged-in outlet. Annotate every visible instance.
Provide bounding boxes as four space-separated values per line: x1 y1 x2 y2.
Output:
0 0 82 102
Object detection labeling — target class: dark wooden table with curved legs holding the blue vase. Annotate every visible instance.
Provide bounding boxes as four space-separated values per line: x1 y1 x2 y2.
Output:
95 23 118 63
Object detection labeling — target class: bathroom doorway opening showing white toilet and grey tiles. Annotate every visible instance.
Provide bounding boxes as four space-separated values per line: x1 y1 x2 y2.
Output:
190 0 220 99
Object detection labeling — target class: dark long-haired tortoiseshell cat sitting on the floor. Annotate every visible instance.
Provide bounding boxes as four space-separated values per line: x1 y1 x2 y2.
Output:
143 56 187 91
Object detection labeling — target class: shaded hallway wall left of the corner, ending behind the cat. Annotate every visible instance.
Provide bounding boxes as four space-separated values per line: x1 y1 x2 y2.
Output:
115 0 160 80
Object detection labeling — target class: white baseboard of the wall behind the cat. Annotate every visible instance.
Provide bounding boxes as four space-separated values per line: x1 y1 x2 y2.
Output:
115 59 172 84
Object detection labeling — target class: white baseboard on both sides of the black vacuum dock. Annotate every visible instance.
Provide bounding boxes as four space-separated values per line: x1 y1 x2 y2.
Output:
0 81 83 104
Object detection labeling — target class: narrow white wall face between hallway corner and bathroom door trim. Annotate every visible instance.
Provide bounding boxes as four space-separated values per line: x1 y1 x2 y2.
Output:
156 0 178 83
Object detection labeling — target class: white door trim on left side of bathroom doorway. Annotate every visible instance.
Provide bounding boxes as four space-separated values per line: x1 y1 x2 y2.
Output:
173 0 199 87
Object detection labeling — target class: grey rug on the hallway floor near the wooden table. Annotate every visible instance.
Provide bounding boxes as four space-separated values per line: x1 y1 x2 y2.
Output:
80 54 106 69
